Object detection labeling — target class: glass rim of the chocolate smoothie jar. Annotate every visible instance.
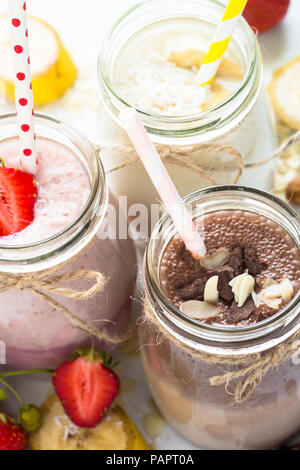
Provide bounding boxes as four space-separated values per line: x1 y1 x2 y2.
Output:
143 185 300 350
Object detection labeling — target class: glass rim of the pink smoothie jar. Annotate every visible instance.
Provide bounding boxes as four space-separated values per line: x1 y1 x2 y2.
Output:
0 112 108 270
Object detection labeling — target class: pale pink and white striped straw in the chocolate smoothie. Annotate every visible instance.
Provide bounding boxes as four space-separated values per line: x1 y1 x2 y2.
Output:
119 108 206 258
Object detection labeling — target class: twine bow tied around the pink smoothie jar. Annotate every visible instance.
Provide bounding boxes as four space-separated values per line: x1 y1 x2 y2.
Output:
0 268 130 344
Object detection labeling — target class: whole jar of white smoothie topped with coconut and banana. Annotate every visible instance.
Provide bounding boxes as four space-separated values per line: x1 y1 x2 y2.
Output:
99 0 275 239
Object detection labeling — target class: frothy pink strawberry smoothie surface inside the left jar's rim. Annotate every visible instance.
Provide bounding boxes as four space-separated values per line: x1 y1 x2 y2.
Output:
0 139 90 246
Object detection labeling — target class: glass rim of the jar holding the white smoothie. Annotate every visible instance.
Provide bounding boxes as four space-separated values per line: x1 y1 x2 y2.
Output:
98 0 262 136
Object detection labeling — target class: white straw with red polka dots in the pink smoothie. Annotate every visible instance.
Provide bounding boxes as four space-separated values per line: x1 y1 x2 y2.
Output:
8 0 37 175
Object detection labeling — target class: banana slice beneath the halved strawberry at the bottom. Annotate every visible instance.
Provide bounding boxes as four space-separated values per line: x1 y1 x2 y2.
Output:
29 395 149 450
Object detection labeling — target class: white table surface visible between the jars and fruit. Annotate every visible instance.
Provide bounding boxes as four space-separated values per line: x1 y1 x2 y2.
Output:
0 0 300 450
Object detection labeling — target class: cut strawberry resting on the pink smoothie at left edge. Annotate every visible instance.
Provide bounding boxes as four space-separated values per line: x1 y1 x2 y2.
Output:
0 167 37 237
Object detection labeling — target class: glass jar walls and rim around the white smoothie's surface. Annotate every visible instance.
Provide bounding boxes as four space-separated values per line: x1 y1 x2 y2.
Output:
98 0 276 241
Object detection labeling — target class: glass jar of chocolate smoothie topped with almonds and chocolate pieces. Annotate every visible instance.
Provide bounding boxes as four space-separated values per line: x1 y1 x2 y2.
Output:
139 187 300 450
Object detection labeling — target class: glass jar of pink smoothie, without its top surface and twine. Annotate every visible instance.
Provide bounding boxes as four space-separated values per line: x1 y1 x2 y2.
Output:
0 114 136 368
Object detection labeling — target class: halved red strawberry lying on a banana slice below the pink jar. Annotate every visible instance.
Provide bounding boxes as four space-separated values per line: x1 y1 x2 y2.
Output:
53 354 120 428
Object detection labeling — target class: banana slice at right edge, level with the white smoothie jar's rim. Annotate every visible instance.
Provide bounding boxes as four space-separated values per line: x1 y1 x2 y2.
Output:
269 56 300 130
